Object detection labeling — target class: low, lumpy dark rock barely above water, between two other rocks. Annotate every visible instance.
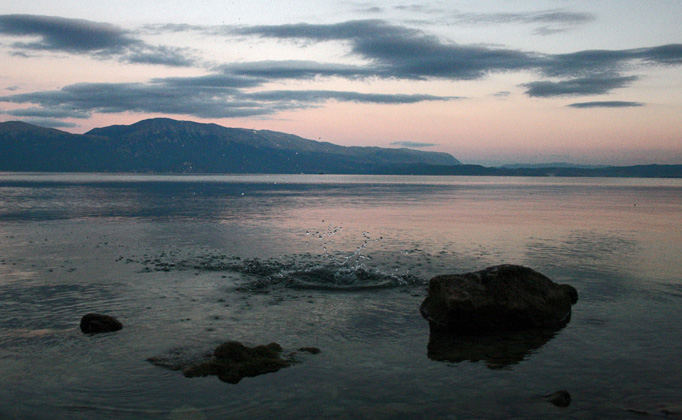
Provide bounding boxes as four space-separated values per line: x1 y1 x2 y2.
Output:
183 341 294 384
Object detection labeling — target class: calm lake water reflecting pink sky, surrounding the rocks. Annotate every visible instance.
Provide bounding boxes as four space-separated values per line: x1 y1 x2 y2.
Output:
0 173 682 420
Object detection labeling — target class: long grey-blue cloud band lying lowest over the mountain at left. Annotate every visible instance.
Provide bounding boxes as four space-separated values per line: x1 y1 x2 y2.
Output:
0 74 455 118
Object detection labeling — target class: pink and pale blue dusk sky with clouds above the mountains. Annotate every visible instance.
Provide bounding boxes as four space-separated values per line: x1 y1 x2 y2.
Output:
0 0 682 165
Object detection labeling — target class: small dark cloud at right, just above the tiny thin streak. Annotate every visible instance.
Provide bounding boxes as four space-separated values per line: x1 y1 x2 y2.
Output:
522 75 638 98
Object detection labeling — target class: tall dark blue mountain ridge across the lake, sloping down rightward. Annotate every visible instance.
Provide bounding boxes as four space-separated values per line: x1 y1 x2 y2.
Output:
0 118 460 174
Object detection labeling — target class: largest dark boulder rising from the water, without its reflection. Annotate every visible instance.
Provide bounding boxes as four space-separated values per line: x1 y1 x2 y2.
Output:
420 265 578 334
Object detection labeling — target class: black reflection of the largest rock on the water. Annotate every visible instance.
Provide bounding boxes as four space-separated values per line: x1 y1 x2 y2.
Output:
427 329 559 369
